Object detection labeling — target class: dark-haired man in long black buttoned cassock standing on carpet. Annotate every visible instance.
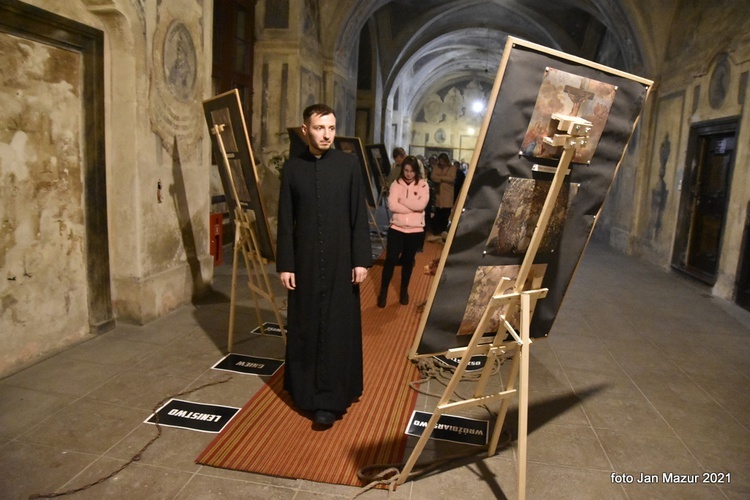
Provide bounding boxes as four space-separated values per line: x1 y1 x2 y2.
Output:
276 104 372 426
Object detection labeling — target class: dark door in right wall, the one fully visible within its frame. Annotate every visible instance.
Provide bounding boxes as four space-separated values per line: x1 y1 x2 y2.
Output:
672 120 738 285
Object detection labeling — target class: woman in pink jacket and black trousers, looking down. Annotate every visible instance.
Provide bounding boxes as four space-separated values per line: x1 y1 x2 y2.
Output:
378 156 430 307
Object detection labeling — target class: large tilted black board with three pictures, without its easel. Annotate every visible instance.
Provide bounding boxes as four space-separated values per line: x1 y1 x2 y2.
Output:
409 38 652 359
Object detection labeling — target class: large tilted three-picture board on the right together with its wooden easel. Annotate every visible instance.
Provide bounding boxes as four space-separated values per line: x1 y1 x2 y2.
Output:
397 37 653 500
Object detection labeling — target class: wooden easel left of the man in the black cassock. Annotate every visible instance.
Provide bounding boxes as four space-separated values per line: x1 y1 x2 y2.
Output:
211 123 286 352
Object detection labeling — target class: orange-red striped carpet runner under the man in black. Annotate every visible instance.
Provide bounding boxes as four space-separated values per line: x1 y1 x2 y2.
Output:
196 243 443 486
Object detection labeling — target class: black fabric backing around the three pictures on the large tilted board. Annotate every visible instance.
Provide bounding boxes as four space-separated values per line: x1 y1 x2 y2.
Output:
415 44 648 356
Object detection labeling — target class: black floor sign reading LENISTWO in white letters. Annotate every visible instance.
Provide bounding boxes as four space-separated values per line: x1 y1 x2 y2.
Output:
145 399 239 432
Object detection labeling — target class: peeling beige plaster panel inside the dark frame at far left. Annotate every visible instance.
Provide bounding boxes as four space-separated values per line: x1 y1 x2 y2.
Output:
0 33 89 374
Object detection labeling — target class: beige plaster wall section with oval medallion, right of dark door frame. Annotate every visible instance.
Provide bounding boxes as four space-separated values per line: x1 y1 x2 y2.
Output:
116 0 213 324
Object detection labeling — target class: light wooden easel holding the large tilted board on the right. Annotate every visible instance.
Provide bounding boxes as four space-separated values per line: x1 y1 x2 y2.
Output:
397 114 592 499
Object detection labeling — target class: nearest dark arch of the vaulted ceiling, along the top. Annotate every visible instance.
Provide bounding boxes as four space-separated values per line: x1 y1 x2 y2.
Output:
336 0 643 71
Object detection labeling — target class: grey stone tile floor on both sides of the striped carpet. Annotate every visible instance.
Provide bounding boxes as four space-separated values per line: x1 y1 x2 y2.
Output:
0 240 750 500
